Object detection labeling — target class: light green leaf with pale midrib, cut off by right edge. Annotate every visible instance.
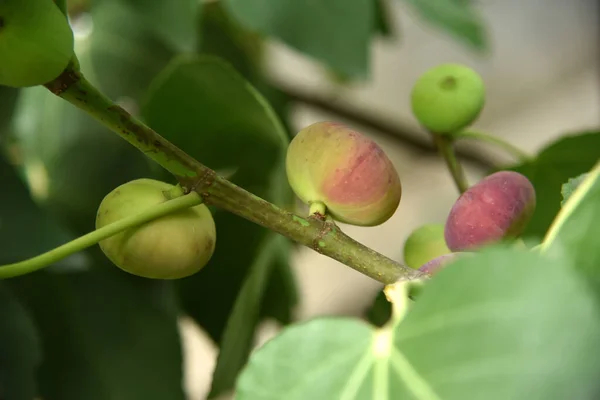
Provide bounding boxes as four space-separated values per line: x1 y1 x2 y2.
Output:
541 162 600 295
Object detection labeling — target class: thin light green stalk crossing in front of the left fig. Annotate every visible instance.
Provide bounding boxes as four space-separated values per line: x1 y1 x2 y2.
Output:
0 192 202 279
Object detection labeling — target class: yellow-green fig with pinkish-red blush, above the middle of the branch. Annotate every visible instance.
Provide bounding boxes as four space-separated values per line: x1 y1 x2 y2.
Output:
286 122 402 226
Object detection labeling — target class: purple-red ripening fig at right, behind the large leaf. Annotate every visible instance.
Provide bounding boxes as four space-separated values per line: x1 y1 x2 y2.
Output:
444 171 536 251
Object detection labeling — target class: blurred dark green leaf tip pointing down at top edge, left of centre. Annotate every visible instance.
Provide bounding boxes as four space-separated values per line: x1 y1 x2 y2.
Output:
109 0 202 52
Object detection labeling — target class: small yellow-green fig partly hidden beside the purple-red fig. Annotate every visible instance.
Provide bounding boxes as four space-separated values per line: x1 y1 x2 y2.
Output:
404 224 451 269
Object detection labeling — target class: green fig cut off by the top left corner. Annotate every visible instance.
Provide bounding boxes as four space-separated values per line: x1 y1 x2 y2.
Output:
0 0 74 87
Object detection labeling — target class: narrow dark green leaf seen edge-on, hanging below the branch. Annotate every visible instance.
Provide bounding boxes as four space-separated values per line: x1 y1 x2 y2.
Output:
209 233 296 398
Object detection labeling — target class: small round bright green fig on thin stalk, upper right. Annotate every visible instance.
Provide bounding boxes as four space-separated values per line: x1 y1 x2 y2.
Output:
411 64 485 134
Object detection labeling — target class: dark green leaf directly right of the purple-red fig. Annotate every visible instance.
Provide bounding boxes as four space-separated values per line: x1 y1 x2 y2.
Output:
510 132 600 238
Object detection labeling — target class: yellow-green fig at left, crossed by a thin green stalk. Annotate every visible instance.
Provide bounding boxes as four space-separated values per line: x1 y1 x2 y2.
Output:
96 179 216 279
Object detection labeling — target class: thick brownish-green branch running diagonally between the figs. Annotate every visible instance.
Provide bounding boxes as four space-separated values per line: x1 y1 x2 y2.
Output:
44 67 423 284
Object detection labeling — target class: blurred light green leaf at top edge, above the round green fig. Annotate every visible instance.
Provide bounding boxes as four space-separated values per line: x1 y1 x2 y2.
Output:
404 0 488 51
